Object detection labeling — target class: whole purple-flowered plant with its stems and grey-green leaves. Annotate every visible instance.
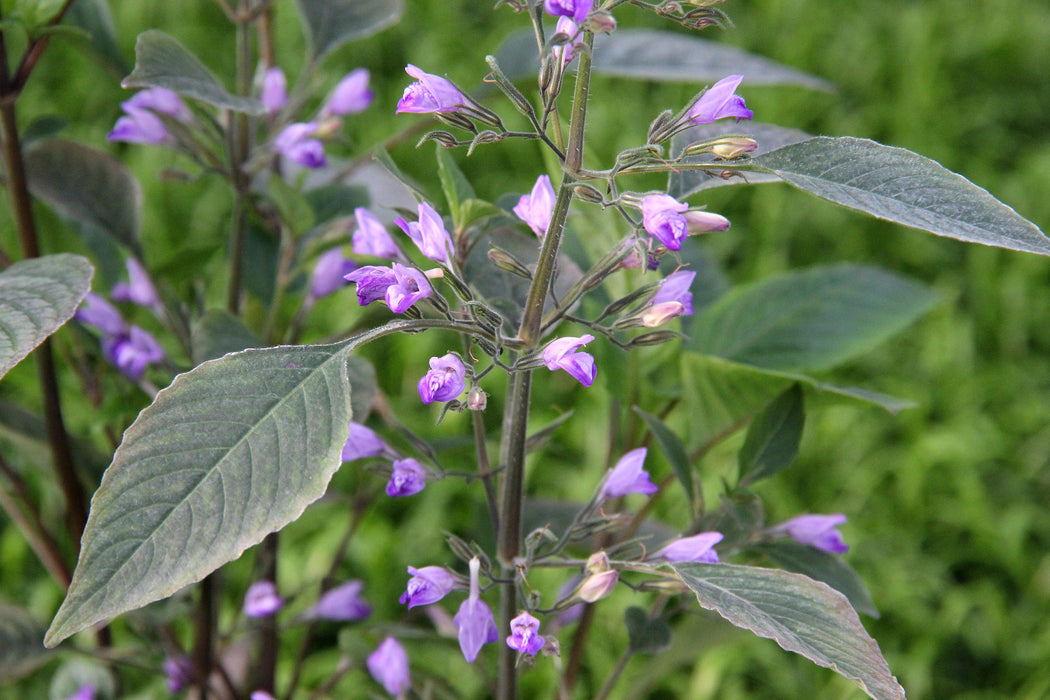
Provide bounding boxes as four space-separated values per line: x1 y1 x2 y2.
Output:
0 0 1050 700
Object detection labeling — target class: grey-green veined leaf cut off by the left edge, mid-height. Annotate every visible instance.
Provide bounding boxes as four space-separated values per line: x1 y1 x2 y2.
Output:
0 253 93 377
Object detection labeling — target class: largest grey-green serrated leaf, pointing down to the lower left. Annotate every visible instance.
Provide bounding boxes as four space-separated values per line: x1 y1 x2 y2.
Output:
44 343 351 646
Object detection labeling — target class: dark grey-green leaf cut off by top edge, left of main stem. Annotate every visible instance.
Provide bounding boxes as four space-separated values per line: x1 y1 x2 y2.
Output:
296 0 404 61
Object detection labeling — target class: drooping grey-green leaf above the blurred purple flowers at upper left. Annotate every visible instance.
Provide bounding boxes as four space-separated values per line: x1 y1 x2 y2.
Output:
121 29 265 114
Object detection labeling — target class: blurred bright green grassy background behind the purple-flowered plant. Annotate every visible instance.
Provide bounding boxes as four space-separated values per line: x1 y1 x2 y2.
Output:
0 0 1050 700
